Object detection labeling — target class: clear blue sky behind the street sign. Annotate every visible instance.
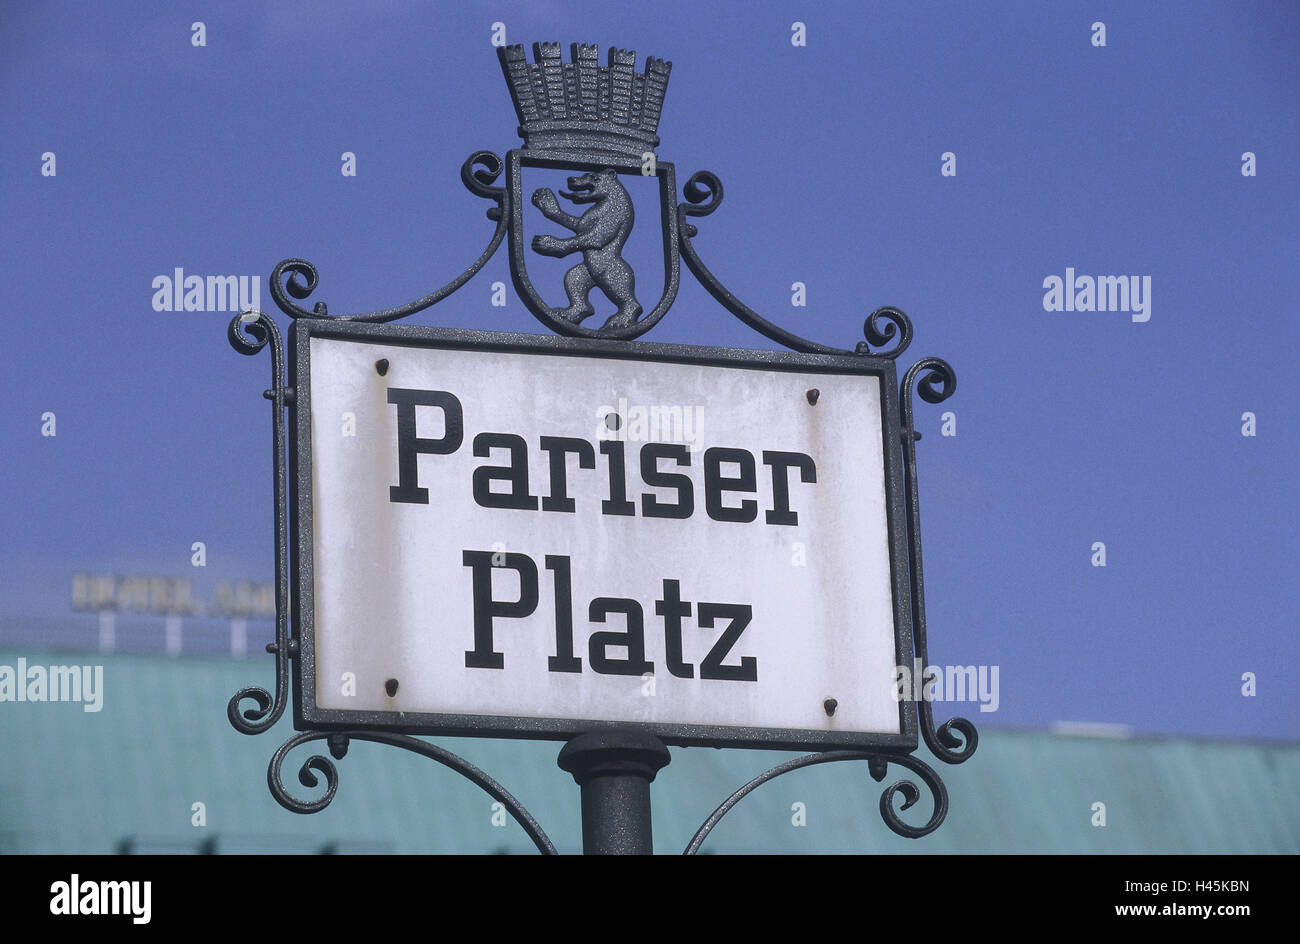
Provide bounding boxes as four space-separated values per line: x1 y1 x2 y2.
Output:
0 1 1300 739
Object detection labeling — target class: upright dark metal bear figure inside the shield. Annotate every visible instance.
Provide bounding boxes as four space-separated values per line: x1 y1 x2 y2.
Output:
533 168 642 328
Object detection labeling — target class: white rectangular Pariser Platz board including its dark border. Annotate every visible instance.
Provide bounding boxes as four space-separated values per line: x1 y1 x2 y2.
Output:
290 320 917 750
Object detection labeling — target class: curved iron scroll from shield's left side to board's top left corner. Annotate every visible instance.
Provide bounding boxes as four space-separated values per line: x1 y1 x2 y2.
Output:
270 151 510 324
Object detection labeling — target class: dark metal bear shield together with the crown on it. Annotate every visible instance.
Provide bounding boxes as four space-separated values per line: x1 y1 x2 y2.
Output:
498 43 680 339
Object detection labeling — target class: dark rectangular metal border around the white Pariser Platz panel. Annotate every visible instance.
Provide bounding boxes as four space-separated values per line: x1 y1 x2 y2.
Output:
289 320 918 752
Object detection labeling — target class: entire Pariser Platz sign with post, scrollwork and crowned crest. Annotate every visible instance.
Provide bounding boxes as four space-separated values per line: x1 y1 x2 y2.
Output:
229 44 978 853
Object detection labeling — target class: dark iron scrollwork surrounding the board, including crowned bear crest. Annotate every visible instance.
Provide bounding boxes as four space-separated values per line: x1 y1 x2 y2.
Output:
228 38 978 854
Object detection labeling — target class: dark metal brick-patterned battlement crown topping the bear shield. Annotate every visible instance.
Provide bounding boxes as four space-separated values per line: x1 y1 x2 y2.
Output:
497 43 672 160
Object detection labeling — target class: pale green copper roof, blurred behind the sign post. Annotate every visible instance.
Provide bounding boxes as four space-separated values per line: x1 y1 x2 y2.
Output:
0 650 1300 853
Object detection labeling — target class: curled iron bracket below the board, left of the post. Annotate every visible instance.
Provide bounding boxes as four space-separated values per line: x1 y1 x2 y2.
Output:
267 731 556 856
